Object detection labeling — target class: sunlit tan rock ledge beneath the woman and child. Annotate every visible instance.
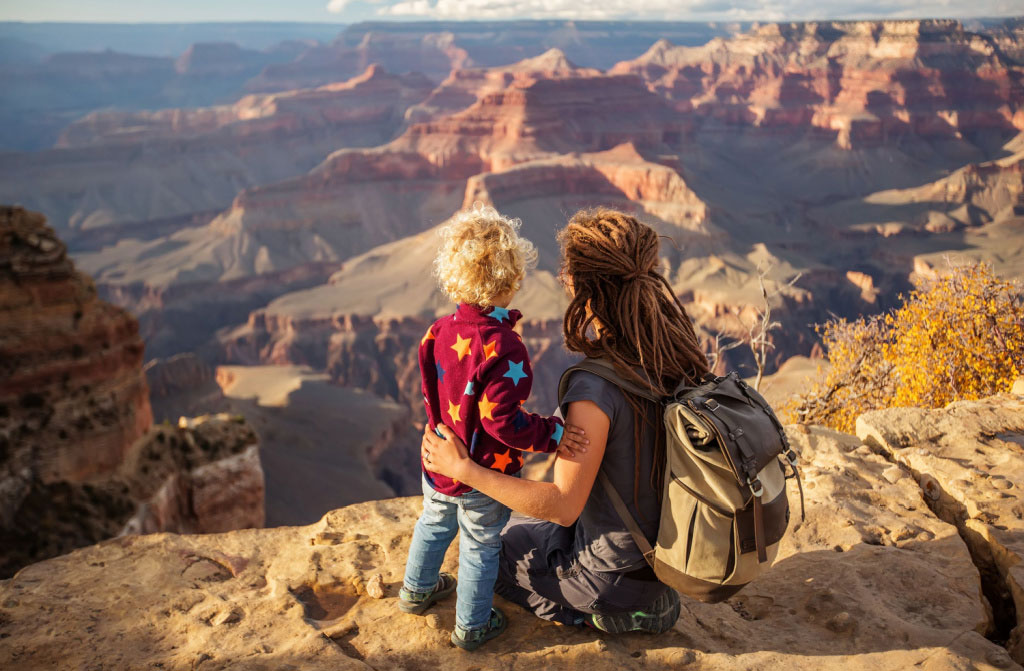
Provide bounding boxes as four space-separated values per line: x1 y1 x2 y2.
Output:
0 396 1024 671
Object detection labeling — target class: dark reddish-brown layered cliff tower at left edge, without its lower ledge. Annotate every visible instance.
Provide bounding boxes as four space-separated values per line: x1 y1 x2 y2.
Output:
0 207 153 485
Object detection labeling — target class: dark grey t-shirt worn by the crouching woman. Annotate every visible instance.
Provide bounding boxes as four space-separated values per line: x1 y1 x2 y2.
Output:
561 371 662 572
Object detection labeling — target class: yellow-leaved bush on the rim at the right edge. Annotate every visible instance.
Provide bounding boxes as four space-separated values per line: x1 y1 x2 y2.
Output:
786 263 1024 432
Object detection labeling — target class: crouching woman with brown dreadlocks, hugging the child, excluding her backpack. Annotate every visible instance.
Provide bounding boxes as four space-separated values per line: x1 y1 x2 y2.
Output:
422 209 708 633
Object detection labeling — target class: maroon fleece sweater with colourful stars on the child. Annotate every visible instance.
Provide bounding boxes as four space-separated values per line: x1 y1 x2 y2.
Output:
420 303 562 496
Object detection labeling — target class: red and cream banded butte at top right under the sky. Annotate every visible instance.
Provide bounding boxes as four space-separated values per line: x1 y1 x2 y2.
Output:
611 20 1024 149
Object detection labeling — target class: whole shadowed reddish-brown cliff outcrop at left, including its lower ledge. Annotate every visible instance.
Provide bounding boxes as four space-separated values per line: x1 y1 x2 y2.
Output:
0 207 263 576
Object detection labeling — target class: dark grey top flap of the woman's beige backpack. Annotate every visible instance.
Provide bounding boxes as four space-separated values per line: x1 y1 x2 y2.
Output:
676 373 788 489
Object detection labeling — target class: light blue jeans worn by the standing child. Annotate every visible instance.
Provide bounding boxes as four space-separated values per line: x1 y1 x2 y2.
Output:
402 477 511 634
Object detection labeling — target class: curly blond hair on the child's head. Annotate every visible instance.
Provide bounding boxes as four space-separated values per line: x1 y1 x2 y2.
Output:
434 203 537 307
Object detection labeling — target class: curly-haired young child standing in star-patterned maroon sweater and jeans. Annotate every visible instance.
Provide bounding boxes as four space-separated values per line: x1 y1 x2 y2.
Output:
399 206 569 649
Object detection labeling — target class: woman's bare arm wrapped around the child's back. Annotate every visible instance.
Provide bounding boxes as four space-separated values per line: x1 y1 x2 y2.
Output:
423 401 609 527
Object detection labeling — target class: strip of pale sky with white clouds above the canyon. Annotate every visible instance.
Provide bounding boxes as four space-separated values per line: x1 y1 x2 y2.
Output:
0 0 1024 24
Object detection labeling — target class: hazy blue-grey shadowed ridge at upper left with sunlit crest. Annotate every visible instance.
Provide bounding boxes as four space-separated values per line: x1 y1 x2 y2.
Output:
0 66 432 238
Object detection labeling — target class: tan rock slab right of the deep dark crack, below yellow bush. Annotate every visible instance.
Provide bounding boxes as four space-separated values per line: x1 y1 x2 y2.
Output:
857 394 1024 664
